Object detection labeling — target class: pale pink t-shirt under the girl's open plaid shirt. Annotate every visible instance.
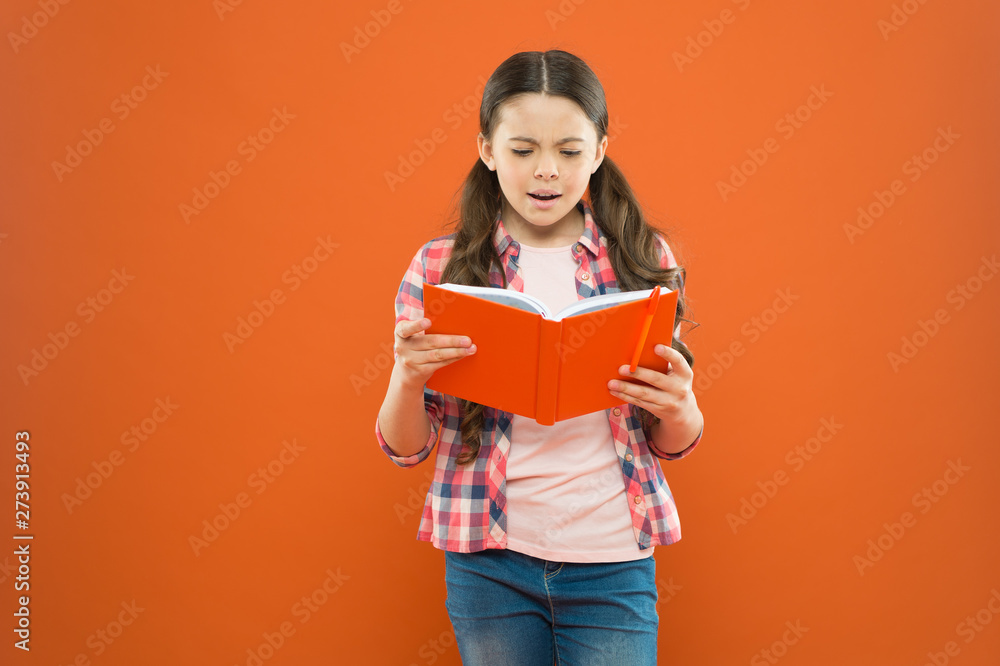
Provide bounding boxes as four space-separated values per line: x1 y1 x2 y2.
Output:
506 243 653 562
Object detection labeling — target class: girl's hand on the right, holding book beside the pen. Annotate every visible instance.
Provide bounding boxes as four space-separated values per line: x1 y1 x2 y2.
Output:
608 344 699 423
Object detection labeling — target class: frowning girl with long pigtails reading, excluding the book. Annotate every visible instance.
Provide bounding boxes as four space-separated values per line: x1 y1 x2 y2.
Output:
375 50 704 666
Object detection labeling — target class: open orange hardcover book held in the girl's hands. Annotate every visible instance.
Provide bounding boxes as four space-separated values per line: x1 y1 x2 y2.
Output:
423 282 677 425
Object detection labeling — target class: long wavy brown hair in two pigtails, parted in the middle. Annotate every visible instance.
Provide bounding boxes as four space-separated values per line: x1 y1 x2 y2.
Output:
441 50 694 464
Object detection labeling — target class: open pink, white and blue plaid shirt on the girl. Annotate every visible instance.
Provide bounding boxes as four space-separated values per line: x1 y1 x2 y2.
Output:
375 200 704 553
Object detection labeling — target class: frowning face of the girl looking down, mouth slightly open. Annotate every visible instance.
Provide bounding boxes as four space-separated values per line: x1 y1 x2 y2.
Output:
478 93 608 244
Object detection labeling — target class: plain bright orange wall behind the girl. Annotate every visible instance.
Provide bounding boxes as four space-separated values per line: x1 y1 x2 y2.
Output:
0 0 1000 666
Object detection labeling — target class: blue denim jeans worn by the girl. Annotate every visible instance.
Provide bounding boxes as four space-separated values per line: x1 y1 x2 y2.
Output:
445 548 659 666
